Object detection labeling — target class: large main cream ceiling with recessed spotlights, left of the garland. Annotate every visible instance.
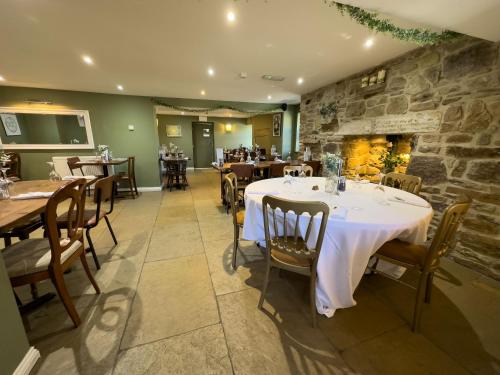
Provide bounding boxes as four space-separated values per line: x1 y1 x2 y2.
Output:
0 0 491 103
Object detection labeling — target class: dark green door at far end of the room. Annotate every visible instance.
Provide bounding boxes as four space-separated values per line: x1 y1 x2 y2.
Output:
193 122 215 168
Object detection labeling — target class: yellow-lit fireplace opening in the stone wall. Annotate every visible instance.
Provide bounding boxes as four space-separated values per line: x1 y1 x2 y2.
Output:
342 134 414 182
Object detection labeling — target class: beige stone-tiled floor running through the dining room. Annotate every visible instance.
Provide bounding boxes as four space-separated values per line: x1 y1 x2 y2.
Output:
10 170 500 375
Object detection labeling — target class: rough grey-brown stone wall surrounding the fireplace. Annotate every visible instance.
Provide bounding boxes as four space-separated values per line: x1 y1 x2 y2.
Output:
300 37 500 279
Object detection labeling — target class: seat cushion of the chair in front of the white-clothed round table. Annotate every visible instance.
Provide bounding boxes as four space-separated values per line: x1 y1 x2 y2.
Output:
271 237 314 268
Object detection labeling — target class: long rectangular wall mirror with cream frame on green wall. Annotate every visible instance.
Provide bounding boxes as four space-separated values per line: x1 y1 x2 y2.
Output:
0 107 94 150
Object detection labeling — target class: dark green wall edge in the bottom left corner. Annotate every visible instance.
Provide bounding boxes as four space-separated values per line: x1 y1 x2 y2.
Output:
0 256 29 374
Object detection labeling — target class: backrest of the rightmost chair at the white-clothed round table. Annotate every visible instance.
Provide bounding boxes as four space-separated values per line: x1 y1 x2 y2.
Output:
424 196 471 269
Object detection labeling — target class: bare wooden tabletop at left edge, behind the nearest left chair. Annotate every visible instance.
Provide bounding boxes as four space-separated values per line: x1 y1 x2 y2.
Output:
0 180 71 231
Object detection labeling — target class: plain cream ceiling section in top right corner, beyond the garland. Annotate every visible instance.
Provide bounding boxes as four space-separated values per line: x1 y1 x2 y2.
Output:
342 0 500 41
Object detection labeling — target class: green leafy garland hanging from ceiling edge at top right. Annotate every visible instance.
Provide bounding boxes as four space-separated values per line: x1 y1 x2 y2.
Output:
323 0 462 45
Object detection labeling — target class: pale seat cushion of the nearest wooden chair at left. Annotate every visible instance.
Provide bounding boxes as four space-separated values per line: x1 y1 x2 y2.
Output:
2 238 82 277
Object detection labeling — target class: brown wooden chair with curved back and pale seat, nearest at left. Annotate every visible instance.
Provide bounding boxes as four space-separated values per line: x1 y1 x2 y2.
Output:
3 179 100 327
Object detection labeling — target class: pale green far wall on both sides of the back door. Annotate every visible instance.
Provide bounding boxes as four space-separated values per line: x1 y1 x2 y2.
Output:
157 115 252 167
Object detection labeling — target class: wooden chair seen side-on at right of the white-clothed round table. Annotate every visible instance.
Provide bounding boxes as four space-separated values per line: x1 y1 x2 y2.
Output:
369 197 471 332
